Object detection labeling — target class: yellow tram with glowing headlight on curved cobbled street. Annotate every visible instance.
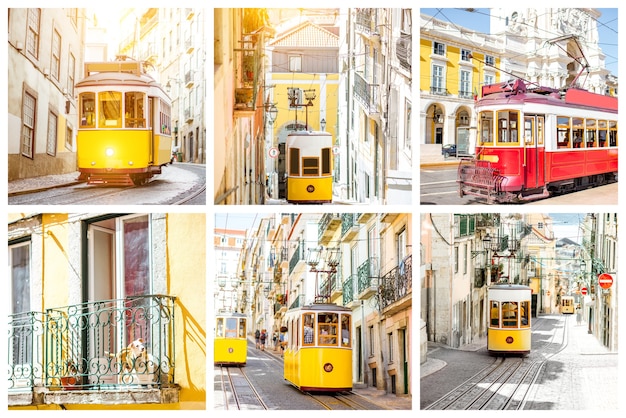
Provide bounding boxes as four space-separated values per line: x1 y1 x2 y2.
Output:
76 58 172 185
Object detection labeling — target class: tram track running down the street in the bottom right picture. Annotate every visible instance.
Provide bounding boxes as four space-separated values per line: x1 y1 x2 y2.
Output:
424 316 570 410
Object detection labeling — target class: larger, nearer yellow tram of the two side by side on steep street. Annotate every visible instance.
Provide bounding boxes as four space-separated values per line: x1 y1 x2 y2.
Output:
284 304 352 392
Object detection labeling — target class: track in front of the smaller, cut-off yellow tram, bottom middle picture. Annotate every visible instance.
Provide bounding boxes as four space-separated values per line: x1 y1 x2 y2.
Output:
219 366 269 410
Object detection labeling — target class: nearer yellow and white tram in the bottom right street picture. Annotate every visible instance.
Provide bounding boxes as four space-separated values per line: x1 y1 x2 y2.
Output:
487 284 532 355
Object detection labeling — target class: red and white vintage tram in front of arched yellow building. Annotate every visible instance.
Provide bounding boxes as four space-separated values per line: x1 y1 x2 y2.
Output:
457 79 618 203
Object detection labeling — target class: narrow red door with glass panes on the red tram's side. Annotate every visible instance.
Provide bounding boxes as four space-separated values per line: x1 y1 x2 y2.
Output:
524 115 545 188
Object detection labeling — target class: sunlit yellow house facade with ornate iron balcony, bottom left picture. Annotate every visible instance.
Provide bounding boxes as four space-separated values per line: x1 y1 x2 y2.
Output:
8 213 206 410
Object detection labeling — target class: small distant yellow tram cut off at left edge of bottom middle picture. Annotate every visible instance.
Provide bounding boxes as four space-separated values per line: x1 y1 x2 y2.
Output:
213 312 248 366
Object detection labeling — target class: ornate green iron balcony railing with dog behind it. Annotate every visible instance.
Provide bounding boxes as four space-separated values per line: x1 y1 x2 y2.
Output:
8 295 175 391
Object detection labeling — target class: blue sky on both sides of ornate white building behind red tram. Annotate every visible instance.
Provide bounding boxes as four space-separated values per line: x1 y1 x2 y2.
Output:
420 8 619 76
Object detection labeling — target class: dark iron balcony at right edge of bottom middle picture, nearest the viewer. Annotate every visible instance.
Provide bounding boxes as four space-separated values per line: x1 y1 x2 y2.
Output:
378 254 413 315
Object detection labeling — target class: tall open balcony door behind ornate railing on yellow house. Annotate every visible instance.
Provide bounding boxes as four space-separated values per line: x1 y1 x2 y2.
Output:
87 215 150 384
